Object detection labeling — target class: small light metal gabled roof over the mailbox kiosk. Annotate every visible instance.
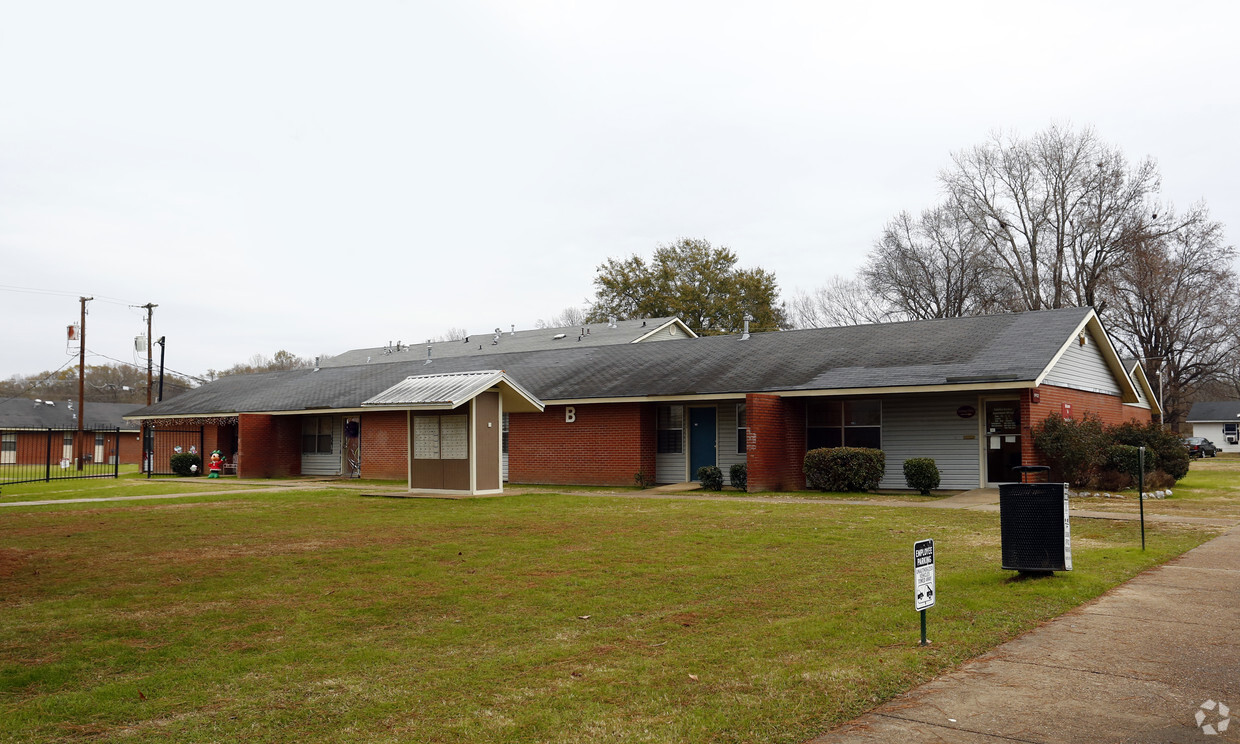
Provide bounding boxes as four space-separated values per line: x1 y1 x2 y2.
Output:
362 370 543 412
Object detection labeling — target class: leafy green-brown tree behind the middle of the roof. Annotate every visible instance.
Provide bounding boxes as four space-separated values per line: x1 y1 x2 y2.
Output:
587 238 787 335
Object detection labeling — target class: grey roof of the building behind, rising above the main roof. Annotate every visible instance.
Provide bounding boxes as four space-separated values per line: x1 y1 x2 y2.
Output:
319 317 697 367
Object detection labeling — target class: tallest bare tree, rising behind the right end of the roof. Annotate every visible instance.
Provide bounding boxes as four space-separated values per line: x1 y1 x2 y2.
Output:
940 126 1170 311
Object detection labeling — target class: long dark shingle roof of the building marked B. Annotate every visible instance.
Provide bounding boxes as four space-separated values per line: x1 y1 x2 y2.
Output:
128 308 1091 415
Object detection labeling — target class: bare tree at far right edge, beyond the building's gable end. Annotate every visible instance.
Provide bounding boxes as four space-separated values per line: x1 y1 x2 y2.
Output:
1109 207 1240 423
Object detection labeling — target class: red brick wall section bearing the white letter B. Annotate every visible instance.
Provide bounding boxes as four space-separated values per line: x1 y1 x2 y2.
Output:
508 403 655 486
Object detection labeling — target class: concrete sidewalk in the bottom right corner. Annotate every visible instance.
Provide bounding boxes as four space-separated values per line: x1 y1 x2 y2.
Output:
812 528 1240 744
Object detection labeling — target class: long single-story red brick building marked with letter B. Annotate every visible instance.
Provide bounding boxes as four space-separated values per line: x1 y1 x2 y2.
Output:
123 309 1158 490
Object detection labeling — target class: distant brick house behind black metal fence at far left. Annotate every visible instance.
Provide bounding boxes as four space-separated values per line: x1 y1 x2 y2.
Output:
0 398 143 465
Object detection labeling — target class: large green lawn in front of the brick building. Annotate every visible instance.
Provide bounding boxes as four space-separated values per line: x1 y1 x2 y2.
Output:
0 489 1211 743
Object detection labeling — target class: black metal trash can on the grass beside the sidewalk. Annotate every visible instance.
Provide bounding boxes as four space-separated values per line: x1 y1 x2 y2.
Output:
999 465 1073 573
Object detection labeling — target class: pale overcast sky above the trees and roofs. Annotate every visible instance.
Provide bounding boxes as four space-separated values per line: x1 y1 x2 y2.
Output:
0 0 1240 377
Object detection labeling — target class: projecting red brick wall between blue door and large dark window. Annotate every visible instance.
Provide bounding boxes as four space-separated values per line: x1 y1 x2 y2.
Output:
745 393 805 491
